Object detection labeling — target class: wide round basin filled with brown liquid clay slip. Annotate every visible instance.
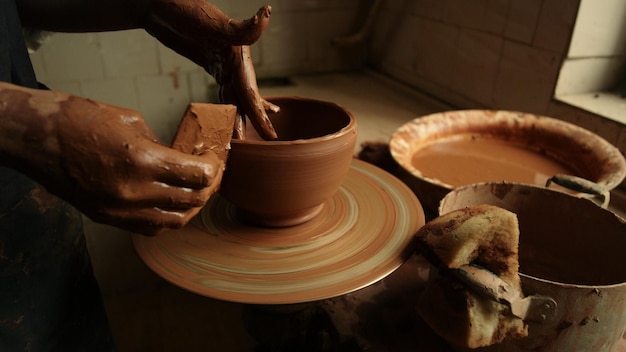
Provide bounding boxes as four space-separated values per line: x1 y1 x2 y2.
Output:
390 110 626 211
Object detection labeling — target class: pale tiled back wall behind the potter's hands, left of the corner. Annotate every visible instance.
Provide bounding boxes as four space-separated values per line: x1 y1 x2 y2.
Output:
31 0 360 142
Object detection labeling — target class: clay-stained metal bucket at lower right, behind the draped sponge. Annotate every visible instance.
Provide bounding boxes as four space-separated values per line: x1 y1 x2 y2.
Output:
439 183 626 352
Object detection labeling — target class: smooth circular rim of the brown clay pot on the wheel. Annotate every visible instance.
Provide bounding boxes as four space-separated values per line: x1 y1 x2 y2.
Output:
231 95 357 146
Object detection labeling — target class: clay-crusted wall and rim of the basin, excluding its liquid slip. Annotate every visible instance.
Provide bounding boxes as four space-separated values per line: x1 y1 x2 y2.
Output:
389 110 626 212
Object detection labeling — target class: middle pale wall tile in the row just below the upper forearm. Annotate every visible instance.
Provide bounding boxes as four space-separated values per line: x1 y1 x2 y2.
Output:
98 29 159 78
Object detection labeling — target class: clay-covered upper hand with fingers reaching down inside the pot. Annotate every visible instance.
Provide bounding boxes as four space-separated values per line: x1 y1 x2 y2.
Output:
144 0 278 139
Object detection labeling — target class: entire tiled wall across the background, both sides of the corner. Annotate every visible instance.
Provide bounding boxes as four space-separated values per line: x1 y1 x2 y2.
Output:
32 0 626 163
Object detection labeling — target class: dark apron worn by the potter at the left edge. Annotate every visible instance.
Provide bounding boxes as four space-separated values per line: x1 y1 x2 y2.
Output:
0 0 114 352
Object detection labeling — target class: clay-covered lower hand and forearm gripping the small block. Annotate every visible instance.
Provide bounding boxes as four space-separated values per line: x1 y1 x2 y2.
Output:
0 83 223 235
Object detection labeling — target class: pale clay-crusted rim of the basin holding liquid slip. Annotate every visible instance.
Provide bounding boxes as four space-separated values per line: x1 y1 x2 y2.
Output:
389 109 626 190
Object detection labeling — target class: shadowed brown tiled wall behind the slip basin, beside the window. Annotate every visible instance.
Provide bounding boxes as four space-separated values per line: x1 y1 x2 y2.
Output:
369 0 626 166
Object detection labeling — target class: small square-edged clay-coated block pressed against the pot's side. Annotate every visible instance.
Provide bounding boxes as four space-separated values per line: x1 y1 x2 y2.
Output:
172 103 237 162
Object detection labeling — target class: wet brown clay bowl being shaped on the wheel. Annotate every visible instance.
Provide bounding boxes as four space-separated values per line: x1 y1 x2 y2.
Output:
220 97 357 227
